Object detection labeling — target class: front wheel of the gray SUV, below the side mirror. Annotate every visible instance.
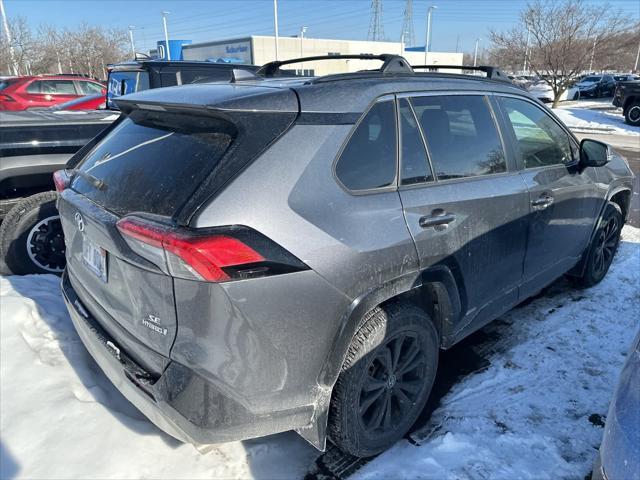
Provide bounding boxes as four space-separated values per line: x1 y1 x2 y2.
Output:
573 202 624 288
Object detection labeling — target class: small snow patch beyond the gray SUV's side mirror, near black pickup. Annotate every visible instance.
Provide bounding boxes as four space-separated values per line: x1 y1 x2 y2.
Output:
553 105 640 135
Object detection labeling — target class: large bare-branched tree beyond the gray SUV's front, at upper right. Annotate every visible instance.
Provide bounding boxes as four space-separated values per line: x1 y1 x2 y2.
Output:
490 0 637 108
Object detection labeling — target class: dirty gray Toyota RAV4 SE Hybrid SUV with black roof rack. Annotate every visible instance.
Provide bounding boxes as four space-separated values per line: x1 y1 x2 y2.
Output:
56 55 632 456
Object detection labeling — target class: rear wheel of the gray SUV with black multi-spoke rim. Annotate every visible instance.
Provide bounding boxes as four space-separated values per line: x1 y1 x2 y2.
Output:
328 303 439 457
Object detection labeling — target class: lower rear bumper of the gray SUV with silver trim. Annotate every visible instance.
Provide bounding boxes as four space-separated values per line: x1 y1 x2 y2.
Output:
62 271 313 444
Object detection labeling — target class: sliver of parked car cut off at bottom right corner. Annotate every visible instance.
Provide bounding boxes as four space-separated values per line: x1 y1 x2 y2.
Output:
592 332 640 480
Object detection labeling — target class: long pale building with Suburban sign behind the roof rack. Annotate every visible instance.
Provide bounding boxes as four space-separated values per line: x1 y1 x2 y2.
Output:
182 35 462 75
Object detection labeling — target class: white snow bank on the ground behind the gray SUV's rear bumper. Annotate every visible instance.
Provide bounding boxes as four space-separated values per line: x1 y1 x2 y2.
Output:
0 275 317 480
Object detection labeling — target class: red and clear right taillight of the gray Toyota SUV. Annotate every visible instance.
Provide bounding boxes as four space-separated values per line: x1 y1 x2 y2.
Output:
116 216 308 282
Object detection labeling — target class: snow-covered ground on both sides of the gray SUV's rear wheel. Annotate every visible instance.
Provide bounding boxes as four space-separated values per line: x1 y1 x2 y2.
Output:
0 226 640 479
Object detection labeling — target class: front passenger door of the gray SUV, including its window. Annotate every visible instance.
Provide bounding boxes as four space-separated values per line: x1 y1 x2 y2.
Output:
498 96 602 298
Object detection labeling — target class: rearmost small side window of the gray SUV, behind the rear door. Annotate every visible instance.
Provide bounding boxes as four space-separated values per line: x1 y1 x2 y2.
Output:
336 101 396 190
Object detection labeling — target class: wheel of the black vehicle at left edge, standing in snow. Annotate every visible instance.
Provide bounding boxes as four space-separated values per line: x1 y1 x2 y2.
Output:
0 192 65 275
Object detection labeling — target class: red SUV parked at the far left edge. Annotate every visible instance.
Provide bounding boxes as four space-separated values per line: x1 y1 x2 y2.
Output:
0 75 107 110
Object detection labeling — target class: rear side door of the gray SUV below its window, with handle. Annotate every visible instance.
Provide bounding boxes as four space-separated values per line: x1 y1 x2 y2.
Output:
400 173 529 327
